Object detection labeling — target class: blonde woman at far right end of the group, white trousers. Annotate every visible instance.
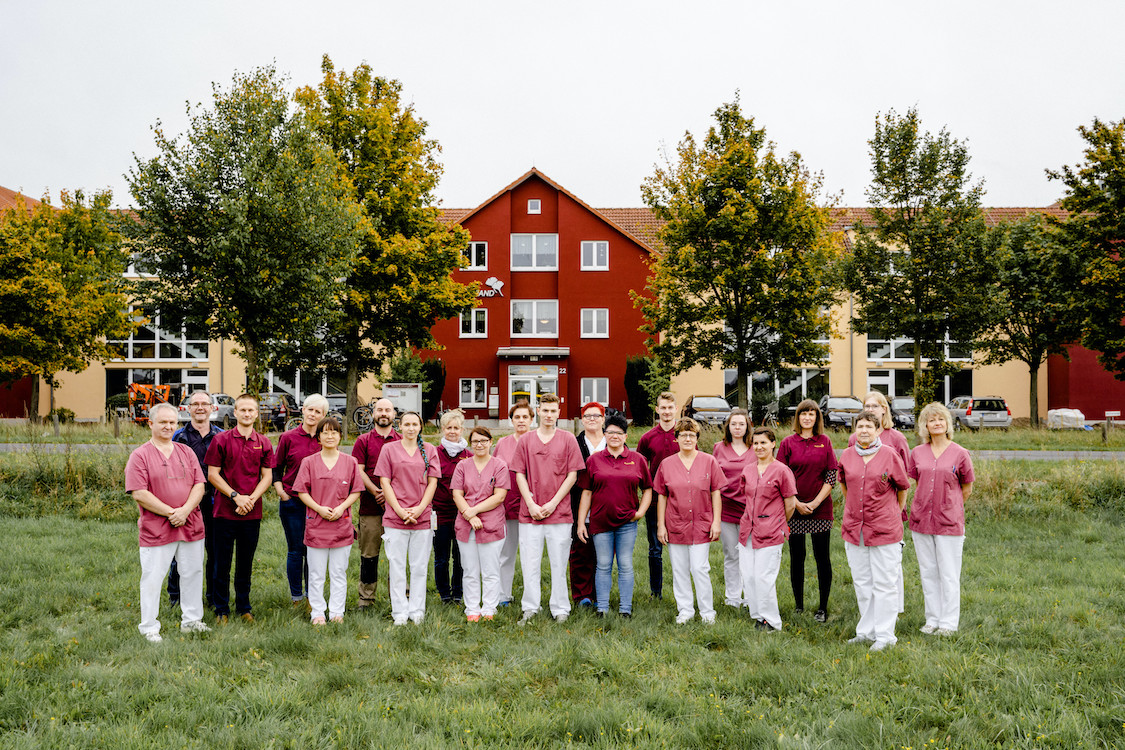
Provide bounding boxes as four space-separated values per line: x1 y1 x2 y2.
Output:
910 403 975 635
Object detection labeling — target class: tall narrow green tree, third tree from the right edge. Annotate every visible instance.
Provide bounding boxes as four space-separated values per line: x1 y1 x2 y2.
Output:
844 108 997 408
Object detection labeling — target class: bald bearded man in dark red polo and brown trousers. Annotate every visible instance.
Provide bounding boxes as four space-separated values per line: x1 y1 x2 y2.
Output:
352 398 403 609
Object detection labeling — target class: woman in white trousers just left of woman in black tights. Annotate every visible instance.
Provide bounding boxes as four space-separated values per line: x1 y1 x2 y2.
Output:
738 427 797 631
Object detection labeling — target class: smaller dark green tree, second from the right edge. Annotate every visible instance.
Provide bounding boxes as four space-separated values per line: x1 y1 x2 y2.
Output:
975 214 1082 427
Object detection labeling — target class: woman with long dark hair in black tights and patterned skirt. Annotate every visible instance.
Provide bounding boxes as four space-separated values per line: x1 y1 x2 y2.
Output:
777 398 836 623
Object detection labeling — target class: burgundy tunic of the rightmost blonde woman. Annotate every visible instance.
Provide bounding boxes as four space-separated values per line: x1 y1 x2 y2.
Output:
910 443 975 536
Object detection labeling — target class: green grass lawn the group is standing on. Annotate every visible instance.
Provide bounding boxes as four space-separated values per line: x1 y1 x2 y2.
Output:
0 459 1125 750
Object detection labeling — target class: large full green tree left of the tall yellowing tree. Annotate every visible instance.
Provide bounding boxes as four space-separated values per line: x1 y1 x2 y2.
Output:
128 67 363 391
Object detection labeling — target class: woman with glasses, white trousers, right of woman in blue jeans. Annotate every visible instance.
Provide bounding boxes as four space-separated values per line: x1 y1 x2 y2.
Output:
653 418 727 625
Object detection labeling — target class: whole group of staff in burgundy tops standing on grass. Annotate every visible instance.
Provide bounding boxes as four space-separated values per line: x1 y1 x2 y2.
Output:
126 391 973 651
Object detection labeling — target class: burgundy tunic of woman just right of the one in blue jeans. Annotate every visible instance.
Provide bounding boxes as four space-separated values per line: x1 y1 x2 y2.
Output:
653 452 727 544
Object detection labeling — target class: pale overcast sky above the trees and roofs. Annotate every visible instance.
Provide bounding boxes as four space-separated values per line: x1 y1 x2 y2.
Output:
0 0 1125 208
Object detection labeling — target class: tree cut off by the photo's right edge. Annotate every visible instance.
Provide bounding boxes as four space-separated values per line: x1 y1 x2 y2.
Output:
1047 118 1125 380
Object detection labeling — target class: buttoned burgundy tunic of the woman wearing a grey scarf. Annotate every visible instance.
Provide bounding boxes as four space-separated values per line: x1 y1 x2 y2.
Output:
839 445 910 546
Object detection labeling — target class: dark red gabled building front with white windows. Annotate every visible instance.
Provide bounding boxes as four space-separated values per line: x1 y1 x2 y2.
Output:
423 170 651 418
